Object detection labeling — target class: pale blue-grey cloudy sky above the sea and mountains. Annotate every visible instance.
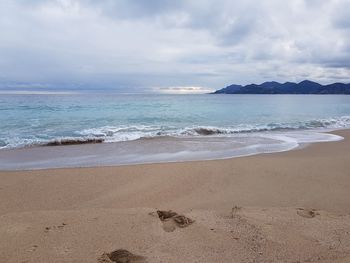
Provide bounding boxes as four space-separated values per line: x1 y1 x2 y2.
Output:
0 0 350 93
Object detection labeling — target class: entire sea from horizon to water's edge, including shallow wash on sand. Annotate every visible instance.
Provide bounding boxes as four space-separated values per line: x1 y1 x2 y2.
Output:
0 93 350 170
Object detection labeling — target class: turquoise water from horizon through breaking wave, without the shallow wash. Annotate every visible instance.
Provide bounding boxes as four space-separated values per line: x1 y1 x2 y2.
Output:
0 94 350 148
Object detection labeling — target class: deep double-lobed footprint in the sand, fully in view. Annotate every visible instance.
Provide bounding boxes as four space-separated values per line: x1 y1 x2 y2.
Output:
157 210 194 232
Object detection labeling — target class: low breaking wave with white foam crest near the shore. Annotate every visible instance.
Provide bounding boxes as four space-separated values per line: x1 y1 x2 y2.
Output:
0 116 350 149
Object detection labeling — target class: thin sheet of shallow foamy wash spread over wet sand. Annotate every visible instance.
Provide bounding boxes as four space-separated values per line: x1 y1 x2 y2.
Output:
0 129 346 171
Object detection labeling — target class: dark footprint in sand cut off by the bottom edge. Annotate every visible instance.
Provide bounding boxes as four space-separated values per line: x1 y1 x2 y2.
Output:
98 249 147 263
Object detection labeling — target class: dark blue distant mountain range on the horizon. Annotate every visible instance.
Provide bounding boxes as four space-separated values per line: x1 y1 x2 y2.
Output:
213 80 350 94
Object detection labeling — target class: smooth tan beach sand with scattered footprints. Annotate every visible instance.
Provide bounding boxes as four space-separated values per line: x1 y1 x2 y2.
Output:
0 130 350 263
